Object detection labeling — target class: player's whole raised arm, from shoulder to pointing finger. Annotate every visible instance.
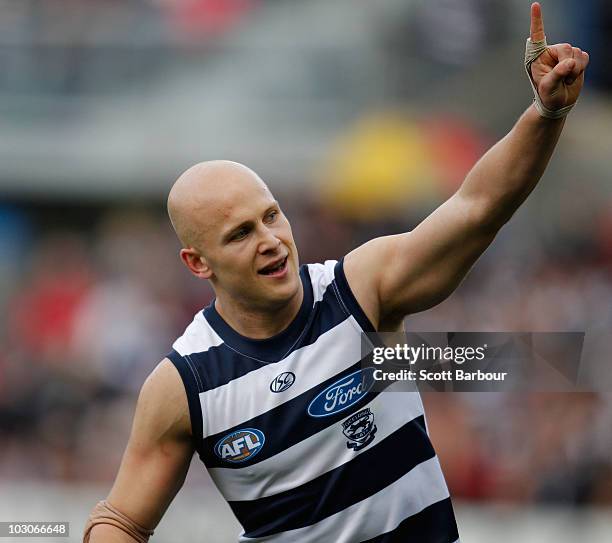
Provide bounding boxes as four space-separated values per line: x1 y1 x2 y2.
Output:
345 3 589 330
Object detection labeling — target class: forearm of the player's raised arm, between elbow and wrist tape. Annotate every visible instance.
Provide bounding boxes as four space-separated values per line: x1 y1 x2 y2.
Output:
459 106 565 229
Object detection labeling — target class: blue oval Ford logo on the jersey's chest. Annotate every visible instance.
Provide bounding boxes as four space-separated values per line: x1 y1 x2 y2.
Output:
308 368 374 417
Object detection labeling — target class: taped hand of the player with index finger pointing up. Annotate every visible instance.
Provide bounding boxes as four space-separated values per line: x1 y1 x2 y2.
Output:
530 2 589 110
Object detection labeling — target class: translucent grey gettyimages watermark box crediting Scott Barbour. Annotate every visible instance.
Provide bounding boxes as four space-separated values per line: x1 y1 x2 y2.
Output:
361 332 584 392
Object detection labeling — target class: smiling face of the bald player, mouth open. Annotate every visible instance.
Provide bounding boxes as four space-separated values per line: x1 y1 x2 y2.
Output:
196 183 300 309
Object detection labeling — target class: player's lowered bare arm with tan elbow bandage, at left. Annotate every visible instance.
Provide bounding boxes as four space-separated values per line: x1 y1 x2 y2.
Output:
84 359 193 543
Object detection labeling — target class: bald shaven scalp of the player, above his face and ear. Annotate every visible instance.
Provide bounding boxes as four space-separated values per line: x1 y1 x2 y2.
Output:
168 160 269 247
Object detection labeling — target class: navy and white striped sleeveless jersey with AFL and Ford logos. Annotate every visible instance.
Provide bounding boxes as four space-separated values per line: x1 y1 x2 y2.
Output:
168 260 459 543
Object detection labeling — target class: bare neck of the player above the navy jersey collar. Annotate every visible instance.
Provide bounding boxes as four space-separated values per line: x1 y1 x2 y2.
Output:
215 281 304 339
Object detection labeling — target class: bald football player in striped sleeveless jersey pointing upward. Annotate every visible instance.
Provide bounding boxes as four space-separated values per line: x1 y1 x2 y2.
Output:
86 3 588 543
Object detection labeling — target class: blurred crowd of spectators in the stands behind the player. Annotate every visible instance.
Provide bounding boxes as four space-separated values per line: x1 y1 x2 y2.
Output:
0 194 612 504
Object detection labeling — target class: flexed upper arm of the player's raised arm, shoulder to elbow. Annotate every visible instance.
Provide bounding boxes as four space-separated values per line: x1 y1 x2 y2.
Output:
346 193 496 322
